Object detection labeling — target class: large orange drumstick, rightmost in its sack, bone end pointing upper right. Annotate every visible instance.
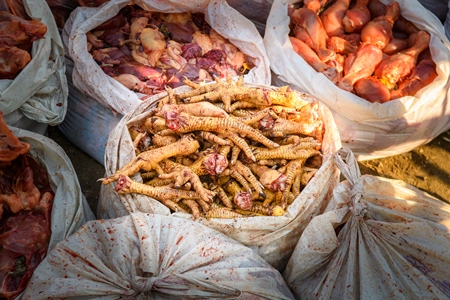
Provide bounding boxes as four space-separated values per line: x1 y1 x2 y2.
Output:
374 31 430 90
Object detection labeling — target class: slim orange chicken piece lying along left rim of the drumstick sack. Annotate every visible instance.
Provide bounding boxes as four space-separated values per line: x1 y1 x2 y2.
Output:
289 36 339 83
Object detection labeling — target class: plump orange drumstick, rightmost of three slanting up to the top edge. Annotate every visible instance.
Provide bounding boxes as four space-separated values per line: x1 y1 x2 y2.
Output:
361 2 400 49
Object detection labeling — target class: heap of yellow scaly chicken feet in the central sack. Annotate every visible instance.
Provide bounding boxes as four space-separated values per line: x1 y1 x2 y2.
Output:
101 76 325 219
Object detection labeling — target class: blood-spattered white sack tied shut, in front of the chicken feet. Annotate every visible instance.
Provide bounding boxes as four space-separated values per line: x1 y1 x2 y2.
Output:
22 213 294 300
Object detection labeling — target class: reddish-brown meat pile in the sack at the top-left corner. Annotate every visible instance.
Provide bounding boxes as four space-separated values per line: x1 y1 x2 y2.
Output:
0 6 47 79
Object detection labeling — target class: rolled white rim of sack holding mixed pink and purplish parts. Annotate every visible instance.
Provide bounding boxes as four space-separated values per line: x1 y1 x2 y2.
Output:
62 0 271 114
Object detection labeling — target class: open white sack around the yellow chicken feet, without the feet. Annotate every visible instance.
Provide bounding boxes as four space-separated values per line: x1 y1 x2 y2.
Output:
97 85 340 271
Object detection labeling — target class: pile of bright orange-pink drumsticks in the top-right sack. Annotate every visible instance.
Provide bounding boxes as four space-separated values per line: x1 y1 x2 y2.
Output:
288 0 437 103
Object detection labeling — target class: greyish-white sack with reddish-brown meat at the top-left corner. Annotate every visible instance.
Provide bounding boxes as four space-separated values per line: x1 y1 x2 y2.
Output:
0 0 68 134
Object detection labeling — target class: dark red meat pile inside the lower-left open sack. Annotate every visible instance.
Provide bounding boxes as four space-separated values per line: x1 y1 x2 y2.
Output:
0 111 54 299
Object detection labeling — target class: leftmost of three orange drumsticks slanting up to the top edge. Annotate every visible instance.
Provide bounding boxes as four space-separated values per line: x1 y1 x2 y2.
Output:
320 0 350 37
